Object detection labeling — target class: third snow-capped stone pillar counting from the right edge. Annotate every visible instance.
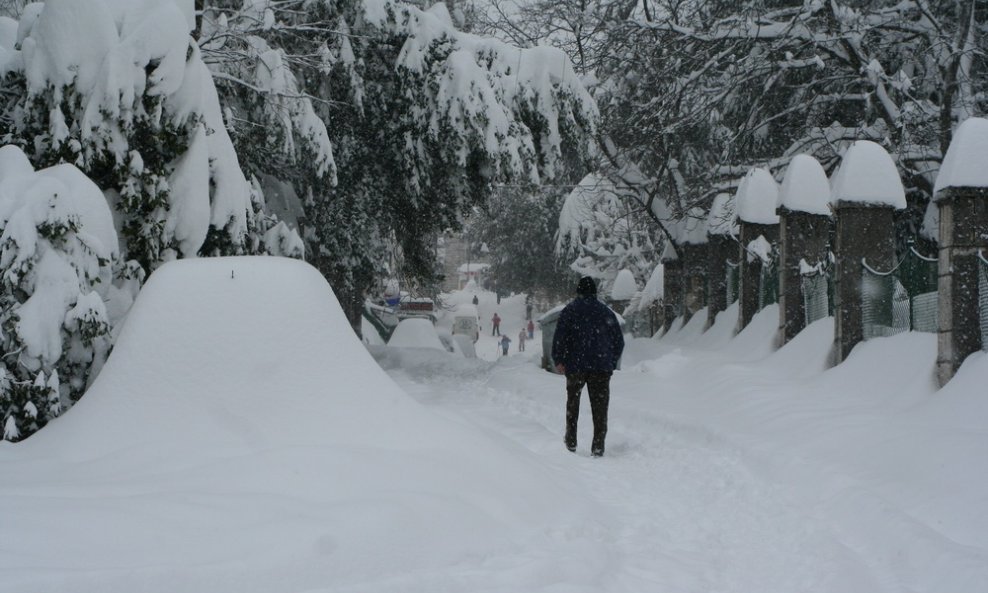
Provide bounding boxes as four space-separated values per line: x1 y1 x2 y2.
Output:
778 154 833 344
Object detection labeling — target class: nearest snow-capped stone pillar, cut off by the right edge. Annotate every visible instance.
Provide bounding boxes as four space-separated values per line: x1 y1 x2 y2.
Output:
933 117 988 385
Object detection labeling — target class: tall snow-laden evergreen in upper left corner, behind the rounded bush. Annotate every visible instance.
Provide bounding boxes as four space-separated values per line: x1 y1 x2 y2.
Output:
0 0 251 270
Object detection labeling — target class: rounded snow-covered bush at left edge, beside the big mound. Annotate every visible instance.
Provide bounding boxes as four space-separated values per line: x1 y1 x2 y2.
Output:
0 146 117 441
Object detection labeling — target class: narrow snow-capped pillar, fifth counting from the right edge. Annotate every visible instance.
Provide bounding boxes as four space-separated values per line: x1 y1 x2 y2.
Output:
707 194 738 328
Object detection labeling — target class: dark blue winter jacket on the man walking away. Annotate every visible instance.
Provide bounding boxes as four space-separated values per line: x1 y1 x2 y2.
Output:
552 296 624 373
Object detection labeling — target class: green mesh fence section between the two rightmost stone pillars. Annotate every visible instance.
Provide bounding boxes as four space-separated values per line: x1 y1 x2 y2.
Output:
861 247 938 340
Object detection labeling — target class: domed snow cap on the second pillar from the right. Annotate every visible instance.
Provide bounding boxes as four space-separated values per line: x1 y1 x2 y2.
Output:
831 140 906 210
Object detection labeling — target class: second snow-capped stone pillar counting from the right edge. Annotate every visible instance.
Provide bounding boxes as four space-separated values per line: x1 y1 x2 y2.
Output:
831 140 906 363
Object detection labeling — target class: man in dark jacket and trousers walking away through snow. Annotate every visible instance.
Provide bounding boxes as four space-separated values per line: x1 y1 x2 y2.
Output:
552 276 624 457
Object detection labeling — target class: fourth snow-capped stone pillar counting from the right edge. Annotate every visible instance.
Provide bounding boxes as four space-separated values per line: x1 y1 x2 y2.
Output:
736 169 779 332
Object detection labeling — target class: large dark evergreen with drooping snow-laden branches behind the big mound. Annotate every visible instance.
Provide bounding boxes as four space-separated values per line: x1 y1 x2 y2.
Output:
202 0 596 320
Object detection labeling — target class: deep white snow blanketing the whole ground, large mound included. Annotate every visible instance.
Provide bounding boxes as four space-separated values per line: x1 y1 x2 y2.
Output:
0 258 988 593
